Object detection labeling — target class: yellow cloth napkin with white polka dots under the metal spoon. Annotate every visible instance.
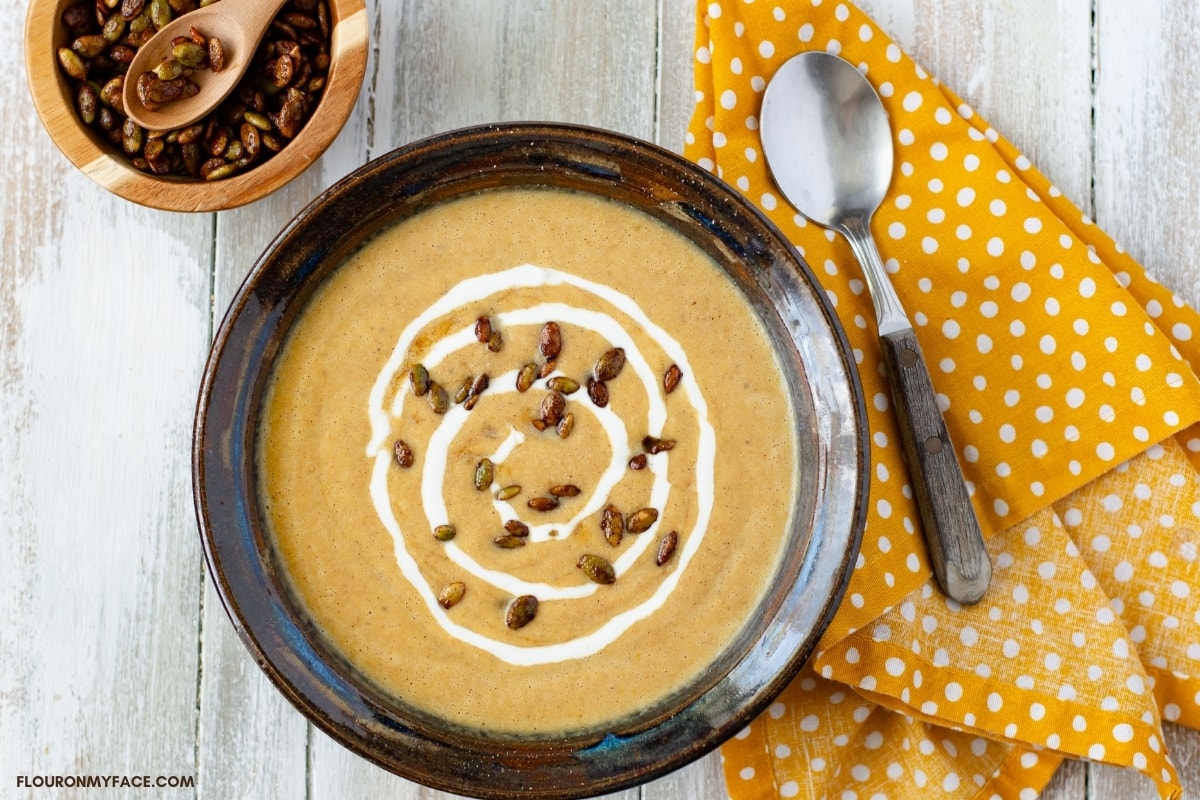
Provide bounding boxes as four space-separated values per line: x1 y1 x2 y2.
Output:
685 0 1200 800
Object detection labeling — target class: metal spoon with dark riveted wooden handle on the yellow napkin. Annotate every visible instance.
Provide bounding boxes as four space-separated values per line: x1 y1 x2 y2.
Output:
760 52 991 603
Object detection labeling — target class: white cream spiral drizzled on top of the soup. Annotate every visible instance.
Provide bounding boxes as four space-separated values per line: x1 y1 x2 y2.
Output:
366 264 716 666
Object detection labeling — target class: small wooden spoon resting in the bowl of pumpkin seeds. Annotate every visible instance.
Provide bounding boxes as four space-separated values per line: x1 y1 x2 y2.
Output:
122 0 287 131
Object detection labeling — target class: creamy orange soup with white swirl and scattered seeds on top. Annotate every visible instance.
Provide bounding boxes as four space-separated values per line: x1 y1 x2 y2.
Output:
258 188 798 735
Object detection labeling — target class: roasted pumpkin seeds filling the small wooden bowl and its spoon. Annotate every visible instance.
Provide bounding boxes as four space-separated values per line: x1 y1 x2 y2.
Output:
56 0 332 180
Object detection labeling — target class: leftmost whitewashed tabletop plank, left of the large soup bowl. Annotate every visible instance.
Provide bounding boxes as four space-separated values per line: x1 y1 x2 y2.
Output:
0 4 211 798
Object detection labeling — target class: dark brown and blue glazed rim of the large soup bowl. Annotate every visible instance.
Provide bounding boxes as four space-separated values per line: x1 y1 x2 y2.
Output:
192 122 870 799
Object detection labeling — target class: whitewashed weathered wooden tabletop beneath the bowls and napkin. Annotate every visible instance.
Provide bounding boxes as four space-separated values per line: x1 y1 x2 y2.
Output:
0 0 1200 800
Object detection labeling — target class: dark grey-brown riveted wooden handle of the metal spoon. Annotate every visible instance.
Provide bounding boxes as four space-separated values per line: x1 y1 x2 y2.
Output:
880 327 991 604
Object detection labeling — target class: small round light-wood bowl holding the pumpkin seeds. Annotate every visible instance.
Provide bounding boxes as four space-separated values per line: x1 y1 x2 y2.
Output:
25 0 367 211
